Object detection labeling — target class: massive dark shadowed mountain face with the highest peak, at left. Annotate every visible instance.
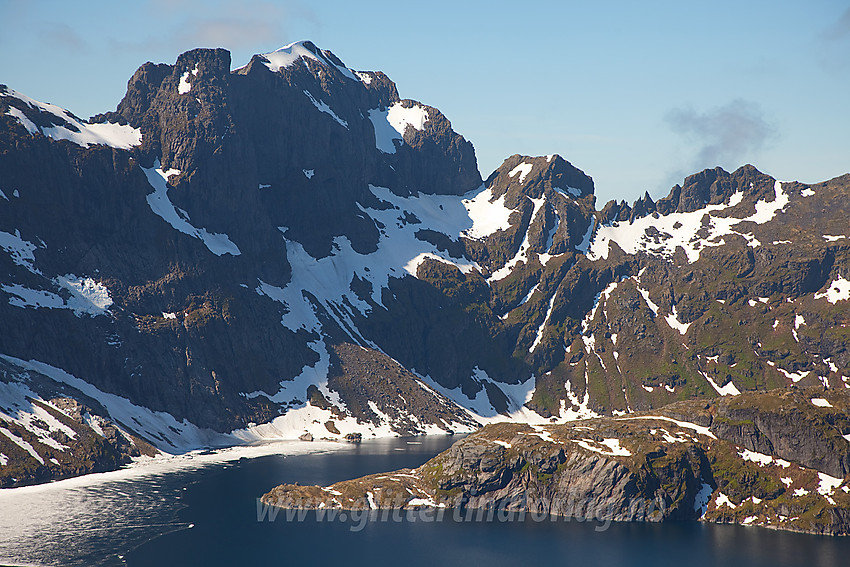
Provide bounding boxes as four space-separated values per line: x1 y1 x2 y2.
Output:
0 42 481 458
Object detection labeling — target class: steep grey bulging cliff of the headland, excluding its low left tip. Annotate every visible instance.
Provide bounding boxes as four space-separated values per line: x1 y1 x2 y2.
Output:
421 424 707 521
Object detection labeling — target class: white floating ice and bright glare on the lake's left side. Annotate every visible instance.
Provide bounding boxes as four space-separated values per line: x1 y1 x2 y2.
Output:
0 442 351 566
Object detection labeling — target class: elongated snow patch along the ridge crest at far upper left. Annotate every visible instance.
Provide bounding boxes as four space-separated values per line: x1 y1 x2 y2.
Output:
0 89 142 150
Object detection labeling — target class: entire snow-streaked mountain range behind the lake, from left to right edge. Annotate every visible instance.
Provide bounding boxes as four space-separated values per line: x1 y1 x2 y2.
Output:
0 38 850 484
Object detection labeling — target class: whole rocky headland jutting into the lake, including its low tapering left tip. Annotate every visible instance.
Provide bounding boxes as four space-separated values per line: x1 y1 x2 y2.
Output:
263 422 710 521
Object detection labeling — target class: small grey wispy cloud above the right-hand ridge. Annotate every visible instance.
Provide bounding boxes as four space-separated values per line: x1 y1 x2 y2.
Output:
667 99 777 171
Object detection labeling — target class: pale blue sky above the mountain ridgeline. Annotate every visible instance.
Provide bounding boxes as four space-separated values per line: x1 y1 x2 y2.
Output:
0 0 850 206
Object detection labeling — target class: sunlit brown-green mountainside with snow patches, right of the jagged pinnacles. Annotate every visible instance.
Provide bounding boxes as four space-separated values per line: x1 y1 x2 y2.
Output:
532 166 848 415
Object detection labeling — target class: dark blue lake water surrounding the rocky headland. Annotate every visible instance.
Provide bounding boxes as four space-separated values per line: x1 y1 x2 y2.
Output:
0 437 850 567
